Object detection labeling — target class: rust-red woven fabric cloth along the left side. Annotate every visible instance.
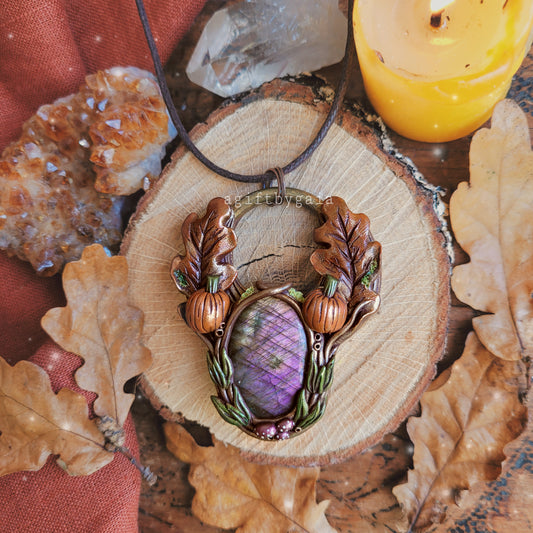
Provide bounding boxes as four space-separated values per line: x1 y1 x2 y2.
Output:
0 0 205 533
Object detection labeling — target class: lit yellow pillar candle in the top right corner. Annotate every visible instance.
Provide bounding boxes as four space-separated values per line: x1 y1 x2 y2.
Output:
353 0 533 142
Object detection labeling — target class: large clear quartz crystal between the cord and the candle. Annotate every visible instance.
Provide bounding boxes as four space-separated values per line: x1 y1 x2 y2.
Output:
187 0 347 96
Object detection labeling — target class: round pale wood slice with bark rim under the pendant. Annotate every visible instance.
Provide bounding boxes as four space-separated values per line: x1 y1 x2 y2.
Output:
122 79 450 465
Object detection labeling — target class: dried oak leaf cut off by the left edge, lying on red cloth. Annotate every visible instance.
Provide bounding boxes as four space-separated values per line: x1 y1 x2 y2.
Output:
0 358 113 475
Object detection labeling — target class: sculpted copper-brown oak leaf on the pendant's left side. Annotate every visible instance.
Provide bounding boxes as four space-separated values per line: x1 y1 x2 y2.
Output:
171 198 237 294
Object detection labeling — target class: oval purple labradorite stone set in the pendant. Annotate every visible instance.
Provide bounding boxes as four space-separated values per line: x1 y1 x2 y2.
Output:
228 296 307 418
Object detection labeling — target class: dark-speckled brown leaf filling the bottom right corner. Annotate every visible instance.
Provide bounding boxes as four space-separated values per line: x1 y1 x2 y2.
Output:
430 380 533 533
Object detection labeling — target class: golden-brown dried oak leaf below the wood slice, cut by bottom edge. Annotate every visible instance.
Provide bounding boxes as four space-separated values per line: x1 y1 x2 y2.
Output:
164 423 335 533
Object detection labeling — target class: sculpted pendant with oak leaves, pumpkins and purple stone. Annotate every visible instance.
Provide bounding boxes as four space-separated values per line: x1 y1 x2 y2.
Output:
171 176 381 440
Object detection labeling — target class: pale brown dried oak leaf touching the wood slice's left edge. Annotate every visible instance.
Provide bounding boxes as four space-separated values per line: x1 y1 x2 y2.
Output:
41 244 151 426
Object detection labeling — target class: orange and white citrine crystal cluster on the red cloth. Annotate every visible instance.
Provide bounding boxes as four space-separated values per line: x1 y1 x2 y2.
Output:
0 67 175 275
